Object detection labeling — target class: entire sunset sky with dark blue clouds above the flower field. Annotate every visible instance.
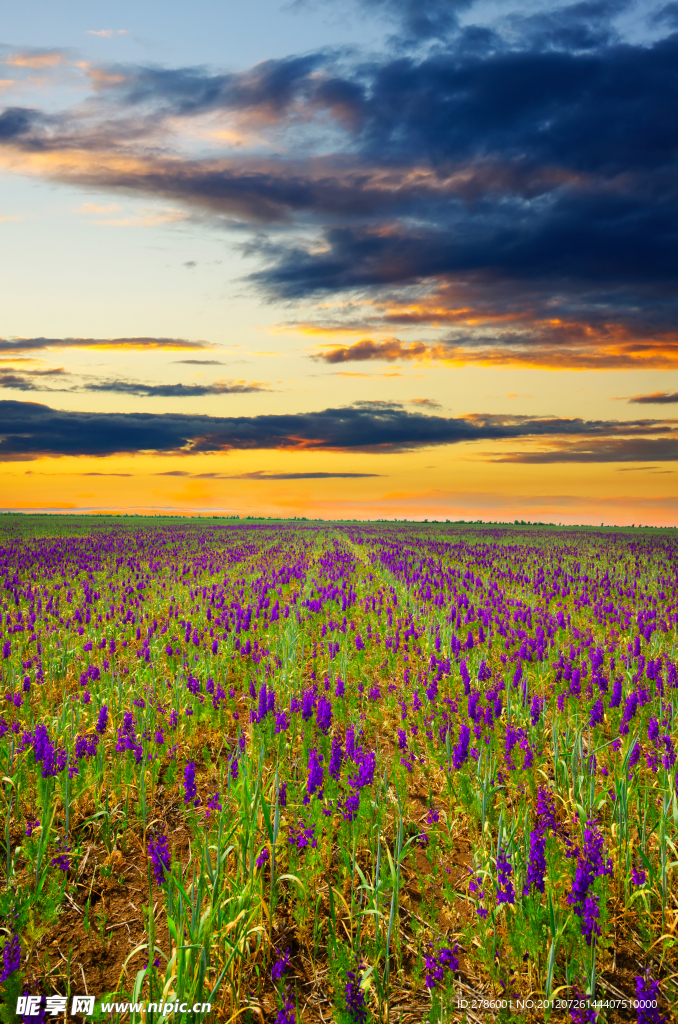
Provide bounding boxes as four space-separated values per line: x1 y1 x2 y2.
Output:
0 0 678 525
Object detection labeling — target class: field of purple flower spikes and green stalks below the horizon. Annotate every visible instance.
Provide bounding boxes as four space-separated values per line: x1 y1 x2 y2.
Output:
0 516 678 1024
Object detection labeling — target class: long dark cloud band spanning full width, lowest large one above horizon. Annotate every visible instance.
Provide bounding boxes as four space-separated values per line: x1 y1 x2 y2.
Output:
0 401 676 462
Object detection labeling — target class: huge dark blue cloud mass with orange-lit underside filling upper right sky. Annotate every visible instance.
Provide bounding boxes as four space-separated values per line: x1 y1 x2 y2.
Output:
0 6 678 369
